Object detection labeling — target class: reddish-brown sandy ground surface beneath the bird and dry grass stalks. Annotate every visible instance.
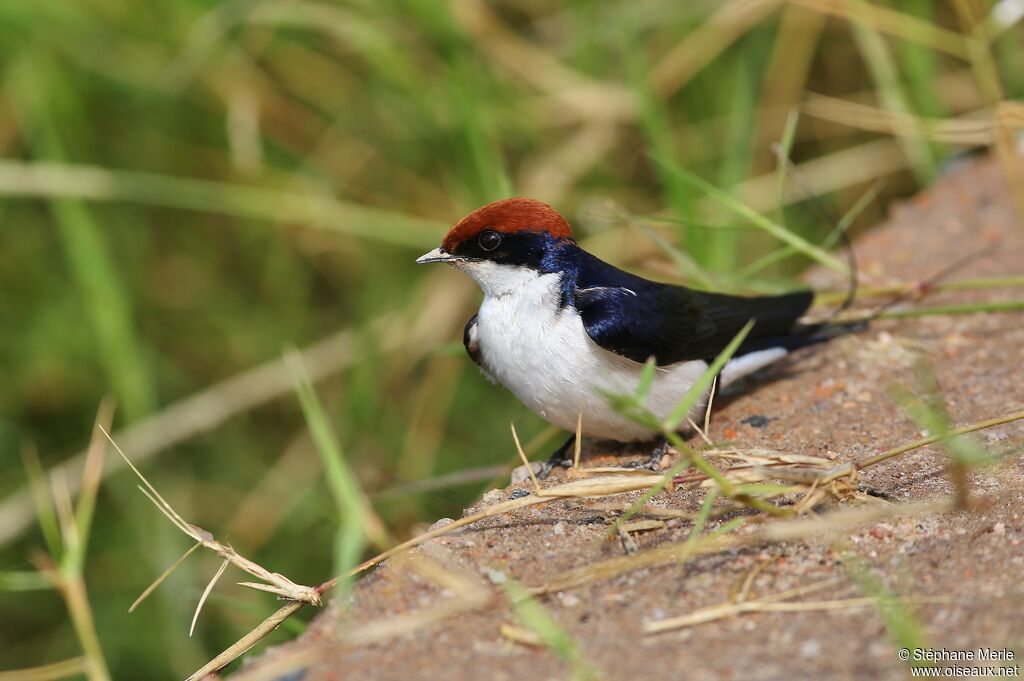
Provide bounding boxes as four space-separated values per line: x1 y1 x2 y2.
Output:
237 156 1024 681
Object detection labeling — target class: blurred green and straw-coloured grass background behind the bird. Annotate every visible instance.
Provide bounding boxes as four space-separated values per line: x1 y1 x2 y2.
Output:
0 0 1024 679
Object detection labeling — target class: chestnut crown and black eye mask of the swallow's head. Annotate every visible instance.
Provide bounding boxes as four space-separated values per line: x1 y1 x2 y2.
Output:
441 198 572 264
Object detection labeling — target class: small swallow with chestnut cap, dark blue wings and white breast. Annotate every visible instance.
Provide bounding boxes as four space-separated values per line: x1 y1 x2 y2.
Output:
416 197 847 473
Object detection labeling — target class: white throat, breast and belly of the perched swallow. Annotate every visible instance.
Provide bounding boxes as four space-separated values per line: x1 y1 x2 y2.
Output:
462 262 708 441
